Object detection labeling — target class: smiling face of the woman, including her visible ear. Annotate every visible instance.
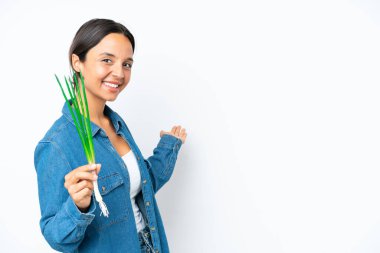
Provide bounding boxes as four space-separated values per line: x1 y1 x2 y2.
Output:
72 33 133 102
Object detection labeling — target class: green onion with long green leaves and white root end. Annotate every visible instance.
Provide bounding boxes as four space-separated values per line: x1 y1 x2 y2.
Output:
55 72 109 217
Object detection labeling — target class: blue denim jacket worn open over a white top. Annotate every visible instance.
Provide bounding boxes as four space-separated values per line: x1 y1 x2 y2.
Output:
34 104 182 253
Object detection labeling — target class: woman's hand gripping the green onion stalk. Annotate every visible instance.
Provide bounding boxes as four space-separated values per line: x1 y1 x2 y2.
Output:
64 164 100 212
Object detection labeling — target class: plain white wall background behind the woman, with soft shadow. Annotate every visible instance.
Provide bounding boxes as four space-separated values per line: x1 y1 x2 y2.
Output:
0 0 380 253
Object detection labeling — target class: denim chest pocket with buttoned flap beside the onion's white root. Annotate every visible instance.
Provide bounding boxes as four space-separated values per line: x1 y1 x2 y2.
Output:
90 172 130 231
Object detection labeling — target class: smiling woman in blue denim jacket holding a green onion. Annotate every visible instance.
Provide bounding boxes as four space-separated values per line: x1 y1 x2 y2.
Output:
34 19 187 253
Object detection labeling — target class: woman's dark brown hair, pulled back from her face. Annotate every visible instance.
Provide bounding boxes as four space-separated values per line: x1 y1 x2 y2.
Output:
69 18 135 71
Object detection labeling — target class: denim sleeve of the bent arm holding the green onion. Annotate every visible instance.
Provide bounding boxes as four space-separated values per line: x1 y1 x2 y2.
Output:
34 142 96 252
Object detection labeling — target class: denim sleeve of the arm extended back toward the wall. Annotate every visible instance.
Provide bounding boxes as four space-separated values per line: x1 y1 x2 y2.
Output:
144 134 182 193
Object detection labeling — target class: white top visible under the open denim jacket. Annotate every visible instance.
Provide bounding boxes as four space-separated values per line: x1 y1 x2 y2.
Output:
122 150 145 232
